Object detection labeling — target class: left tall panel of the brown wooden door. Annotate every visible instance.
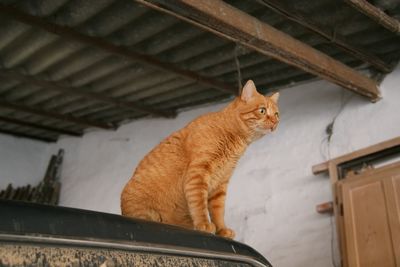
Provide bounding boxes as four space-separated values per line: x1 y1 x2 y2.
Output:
343 177 396 267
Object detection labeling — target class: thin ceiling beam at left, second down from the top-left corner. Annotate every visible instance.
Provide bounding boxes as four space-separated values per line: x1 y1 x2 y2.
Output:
0 69 176 118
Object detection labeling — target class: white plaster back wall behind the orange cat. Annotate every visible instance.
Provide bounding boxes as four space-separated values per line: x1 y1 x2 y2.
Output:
1 65 400 267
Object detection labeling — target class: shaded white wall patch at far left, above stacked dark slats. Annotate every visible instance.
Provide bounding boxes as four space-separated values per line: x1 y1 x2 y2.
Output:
0 134 50 189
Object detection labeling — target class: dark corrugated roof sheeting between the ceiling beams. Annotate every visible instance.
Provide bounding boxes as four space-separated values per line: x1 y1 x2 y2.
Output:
0 0 400 140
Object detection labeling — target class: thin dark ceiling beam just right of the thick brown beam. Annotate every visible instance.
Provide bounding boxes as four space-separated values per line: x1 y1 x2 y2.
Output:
257 0 393 73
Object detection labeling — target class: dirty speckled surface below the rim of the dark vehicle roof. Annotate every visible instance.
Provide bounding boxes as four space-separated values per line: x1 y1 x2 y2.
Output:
0 245 251 267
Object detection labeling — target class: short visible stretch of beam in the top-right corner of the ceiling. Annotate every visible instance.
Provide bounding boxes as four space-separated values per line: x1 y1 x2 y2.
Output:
345 0 400 35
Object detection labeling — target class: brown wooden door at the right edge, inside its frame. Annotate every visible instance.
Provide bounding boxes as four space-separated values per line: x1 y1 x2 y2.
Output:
337 163 400 267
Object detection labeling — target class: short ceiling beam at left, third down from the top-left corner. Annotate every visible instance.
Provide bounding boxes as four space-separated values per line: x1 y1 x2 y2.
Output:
0 99 115 129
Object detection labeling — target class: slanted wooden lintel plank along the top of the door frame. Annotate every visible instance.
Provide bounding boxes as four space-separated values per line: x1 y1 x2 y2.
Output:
311 137 400 175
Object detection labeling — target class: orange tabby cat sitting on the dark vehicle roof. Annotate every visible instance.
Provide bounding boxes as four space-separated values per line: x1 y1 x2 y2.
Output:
121 80 279 238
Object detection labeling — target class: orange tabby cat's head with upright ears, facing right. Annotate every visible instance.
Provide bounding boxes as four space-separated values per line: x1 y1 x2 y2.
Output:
237 80 279 139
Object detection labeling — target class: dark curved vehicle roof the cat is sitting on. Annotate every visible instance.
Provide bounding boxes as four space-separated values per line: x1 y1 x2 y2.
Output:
0 201 270 266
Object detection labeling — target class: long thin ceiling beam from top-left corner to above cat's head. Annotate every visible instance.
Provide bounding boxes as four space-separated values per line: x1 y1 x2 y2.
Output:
0 4 238 95
